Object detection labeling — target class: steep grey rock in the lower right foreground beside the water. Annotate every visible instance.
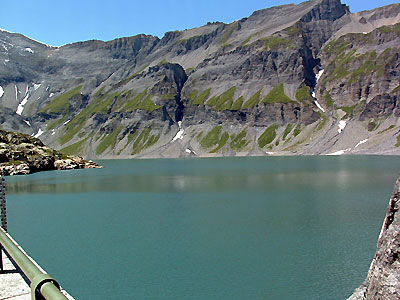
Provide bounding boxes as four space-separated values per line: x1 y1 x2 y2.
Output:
348 178 400 300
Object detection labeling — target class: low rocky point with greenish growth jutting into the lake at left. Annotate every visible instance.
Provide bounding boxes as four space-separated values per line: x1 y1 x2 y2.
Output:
0 129 101 176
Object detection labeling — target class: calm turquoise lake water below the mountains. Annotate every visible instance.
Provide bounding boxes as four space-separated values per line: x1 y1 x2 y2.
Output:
3 156 400 300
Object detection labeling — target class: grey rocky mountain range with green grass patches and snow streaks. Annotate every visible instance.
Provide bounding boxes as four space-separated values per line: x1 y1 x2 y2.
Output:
0 0 400 158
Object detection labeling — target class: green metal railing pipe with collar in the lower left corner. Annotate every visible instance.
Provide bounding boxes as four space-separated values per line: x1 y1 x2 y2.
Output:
0 228 68 300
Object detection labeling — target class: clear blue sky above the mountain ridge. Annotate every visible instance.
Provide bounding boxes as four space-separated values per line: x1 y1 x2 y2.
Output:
0 0 398 46
